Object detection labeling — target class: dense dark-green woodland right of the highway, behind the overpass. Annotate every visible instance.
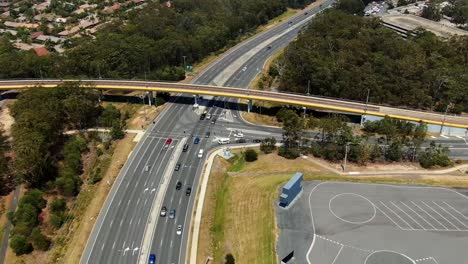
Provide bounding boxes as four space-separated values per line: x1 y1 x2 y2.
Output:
276 10 468 113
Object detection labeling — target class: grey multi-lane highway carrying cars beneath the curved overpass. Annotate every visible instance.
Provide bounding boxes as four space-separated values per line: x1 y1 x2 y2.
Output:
81 2 336 263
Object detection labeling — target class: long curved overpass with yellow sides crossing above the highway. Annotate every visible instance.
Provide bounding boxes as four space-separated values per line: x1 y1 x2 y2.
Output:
0 80 468 131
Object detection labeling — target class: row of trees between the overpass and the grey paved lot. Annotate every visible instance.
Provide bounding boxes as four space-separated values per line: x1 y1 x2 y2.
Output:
272 108 453 169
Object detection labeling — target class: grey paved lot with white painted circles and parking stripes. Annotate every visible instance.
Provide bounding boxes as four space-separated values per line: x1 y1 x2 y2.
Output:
277 182 468 264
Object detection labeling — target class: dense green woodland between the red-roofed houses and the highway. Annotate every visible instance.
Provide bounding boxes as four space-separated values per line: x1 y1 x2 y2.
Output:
0 0 312 80
